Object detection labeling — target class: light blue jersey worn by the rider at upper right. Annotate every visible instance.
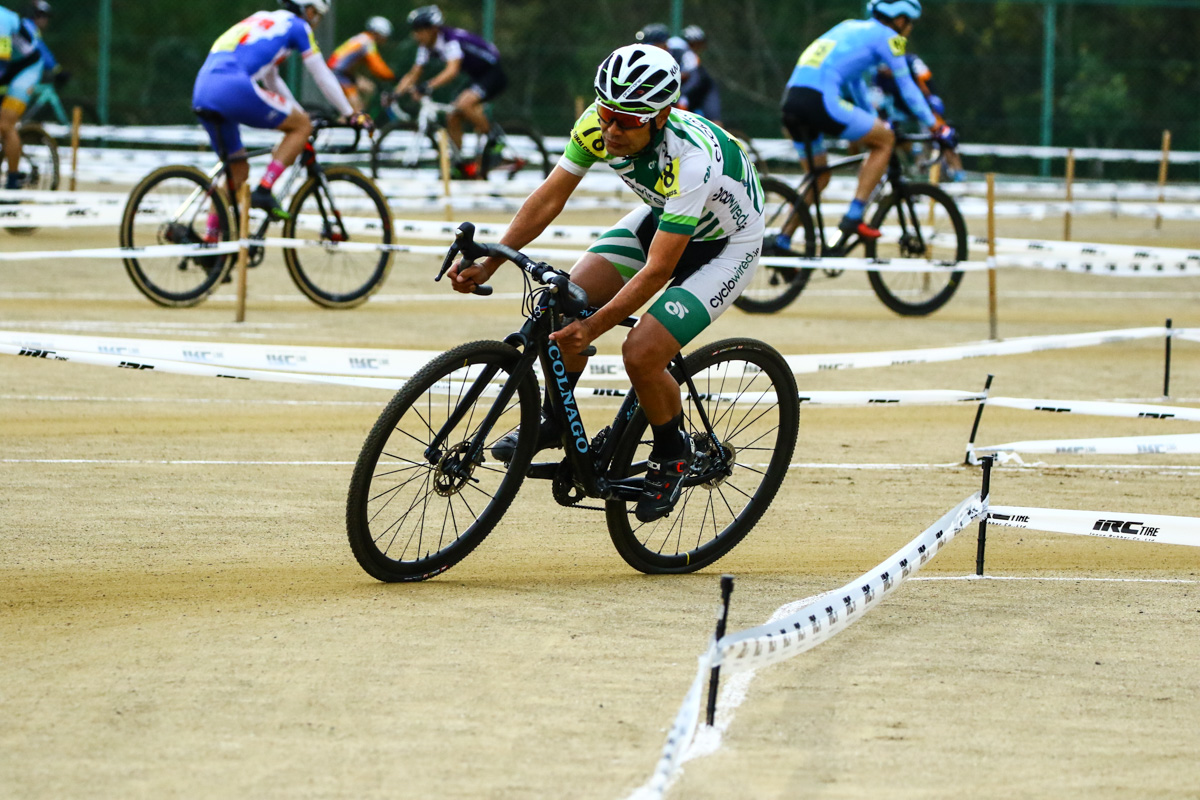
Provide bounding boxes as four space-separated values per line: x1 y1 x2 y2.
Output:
787 19 937 127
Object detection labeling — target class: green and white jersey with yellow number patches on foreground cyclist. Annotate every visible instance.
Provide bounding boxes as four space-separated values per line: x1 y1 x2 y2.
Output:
558 103 763 245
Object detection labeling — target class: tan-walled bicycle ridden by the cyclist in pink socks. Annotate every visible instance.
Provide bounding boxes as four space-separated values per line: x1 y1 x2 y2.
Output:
121 119 392 308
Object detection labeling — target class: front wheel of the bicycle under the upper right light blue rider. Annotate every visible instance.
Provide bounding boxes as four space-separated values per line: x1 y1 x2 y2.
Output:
864 184 968 317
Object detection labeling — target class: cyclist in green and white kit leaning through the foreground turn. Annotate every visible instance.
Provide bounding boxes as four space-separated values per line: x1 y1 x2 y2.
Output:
449 44 763 522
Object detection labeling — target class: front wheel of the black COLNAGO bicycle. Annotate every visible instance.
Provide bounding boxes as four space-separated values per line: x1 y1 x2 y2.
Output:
346 342 541 582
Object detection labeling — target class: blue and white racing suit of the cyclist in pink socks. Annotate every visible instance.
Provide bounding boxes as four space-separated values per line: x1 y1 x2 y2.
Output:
192 10 354 154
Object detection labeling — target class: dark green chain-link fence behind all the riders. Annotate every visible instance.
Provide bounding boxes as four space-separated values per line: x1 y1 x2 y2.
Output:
32 0 1200 176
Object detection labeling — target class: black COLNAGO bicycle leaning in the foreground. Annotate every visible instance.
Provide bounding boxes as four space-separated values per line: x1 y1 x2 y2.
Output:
346 223 799 582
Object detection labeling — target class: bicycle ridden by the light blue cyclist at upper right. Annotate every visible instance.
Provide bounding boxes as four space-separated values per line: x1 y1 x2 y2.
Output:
734 132 968 317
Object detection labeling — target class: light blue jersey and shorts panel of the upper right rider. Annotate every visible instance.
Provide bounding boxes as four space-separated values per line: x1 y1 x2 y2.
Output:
787 18 937 152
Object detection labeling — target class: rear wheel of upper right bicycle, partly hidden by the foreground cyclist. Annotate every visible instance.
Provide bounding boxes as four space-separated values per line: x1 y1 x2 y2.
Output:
733 178 817 314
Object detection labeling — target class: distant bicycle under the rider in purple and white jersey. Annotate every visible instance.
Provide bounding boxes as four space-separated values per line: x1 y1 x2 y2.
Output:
371 95 553 179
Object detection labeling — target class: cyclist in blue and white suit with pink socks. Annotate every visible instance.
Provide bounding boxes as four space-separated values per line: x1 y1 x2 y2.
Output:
192 0 371 220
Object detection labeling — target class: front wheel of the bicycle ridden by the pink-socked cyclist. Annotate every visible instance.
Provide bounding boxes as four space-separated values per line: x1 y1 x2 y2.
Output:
283 167 392 308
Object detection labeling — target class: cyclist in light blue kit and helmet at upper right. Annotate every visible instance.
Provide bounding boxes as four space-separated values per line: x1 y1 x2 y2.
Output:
780 0 954 245
